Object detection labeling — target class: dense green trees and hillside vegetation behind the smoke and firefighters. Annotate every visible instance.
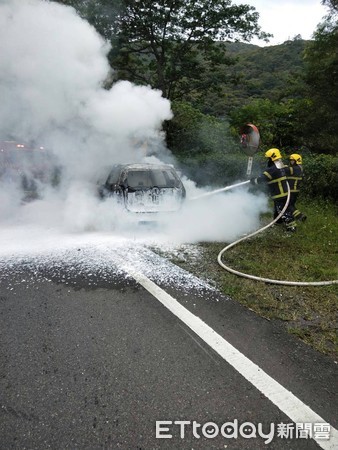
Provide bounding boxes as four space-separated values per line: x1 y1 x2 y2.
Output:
51 0 338 198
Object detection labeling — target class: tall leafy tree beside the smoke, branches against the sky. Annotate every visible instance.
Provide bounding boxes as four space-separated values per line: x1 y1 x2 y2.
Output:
51 0 271 100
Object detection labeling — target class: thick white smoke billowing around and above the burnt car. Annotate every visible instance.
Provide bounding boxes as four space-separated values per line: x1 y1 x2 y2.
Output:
0 0 267 251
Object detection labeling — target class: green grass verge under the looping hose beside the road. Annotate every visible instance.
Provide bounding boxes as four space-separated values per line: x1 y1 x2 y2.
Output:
159 201 338 359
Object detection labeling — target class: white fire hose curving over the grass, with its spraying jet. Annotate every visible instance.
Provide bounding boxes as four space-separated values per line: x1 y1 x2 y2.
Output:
191 180 338 286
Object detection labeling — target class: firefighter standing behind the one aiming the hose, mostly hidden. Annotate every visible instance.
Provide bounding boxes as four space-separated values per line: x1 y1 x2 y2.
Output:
285 153 306 222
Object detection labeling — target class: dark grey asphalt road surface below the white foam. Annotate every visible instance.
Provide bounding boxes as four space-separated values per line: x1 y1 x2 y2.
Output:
0 258 338 450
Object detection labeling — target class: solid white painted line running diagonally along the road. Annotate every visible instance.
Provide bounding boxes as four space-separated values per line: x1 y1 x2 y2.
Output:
126 268 338 450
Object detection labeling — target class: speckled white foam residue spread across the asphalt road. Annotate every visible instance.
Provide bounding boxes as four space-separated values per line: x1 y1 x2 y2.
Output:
0 234 214 294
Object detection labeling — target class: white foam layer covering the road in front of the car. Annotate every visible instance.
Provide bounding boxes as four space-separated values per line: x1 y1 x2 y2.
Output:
0 223 214 292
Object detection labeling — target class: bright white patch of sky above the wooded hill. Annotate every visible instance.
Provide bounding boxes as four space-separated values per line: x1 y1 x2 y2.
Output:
242 0 328 46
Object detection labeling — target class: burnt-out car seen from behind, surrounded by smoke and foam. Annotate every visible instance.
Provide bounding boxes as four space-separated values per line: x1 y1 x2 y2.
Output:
99 164 186 213
